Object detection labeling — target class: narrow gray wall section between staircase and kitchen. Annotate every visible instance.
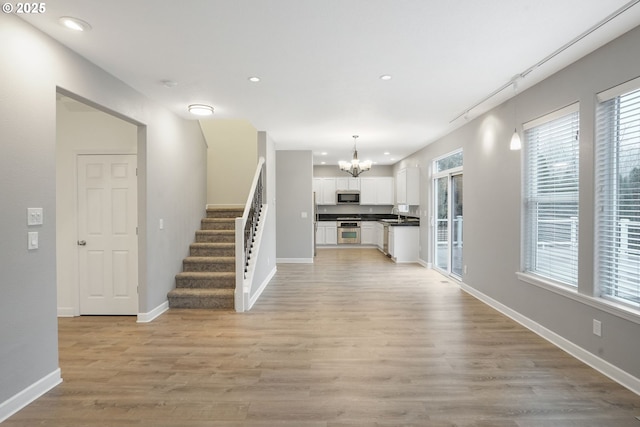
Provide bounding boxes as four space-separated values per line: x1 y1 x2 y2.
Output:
276 150 313 262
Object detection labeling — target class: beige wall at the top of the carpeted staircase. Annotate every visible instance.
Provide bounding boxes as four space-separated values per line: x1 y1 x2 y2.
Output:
200 118 258 206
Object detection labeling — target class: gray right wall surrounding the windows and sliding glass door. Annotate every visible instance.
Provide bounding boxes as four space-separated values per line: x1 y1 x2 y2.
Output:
395 27 640 378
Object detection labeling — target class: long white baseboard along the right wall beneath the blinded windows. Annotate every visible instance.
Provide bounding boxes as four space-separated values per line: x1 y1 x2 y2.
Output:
460 283 640 395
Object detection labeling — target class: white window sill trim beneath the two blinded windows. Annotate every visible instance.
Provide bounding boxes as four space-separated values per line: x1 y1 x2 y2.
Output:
516 272 640 325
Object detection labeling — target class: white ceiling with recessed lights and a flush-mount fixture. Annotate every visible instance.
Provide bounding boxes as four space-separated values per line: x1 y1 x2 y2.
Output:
20 0 640 164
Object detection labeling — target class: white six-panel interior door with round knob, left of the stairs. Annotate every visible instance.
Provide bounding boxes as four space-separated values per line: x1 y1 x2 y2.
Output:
78 154 138 315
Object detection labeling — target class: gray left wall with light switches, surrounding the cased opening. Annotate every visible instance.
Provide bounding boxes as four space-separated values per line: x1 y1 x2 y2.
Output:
0 14 206 403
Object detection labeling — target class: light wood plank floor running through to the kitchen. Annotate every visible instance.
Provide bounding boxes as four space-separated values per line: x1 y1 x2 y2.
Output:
3 249 640 427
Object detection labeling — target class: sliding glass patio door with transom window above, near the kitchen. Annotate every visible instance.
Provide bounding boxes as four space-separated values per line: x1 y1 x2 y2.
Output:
432 150 464 278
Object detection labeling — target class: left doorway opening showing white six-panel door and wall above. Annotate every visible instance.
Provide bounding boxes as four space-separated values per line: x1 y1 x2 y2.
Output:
56 91 144 317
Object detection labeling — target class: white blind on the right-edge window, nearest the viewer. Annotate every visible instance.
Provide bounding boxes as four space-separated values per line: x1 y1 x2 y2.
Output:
596 79 640 307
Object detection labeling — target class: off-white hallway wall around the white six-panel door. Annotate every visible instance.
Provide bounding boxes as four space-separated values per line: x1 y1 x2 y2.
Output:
56 96 138 316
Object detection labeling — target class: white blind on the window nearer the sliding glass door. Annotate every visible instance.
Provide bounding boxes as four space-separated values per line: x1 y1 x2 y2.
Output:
524 104 580 286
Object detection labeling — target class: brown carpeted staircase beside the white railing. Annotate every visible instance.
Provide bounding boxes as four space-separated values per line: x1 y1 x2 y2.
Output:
167 208 243 310
